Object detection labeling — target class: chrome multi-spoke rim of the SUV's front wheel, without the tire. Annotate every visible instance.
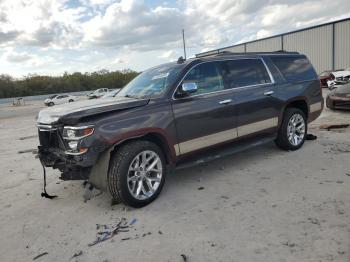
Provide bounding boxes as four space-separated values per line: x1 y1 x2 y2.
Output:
127 150 163 200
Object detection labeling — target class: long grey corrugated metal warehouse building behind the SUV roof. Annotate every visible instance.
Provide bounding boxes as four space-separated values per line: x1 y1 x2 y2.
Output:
196 18 350 73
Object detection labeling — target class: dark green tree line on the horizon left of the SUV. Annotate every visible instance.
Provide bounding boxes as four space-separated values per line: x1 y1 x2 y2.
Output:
0 70 139 98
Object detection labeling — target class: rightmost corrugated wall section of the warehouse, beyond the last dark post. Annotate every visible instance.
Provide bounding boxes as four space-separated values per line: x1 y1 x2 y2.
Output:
334 21 350 69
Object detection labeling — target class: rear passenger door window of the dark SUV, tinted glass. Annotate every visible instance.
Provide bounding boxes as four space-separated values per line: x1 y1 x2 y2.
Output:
220 59 271 88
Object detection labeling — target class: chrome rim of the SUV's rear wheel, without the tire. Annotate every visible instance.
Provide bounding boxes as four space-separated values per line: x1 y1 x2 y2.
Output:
287 114 305 146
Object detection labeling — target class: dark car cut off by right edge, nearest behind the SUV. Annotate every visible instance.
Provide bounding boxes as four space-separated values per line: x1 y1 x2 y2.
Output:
326 83 350 110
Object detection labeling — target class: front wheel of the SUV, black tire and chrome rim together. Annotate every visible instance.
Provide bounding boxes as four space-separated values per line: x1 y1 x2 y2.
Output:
108 140 167 208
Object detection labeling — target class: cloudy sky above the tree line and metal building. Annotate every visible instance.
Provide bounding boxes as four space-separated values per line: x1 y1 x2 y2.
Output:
0 0 350 77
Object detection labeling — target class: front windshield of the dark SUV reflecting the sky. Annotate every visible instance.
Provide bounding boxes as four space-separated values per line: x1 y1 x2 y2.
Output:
117 64 184 98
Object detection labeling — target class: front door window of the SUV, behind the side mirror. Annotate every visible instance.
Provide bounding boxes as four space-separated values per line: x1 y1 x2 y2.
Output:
183 62 224 95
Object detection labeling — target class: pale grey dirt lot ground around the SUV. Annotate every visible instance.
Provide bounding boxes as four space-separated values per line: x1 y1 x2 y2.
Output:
0 96 350 262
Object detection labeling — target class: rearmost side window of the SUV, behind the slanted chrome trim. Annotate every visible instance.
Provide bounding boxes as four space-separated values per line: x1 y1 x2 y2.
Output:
271 56 317 81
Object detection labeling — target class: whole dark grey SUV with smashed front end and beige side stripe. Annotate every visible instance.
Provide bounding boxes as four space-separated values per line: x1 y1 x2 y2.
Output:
37 52 323 207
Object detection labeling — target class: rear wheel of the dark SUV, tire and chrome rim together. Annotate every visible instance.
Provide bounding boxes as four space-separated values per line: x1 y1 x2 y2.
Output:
275 108 307 151
